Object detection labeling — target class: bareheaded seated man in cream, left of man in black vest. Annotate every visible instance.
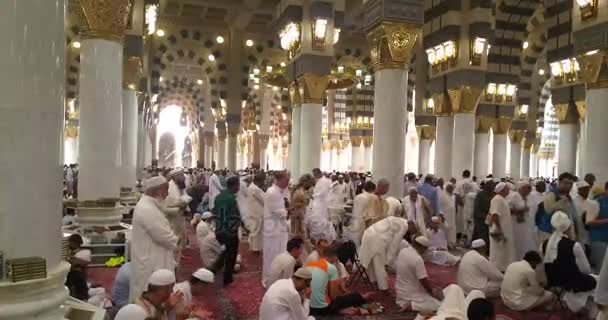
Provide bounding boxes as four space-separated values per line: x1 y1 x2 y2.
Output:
500 251 553 311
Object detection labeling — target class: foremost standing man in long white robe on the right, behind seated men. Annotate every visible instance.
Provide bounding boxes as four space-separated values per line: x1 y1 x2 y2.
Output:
486 182 515 271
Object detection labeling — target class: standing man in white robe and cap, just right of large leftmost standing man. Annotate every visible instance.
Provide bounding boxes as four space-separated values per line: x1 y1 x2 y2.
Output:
165 168 192 264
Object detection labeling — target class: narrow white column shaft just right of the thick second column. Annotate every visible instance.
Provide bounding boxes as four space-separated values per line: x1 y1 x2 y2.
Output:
120 89 138 188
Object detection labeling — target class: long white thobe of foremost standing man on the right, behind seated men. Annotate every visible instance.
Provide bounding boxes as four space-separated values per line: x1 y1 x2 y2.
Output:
490 195 515 271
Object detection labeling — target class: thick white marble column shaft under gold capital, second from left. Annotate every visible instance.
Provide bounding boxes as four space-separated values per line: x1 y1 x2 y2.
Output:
78 39 122 200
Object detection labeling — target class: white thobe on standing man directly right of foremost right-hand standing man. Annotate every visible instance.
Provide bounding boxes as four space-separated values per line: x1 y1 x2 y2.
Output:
507 192 538 260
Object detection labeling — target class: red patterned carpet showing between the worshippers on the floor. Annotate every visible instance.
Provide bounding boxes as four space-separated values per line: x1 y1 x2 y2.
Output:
89 229 566 320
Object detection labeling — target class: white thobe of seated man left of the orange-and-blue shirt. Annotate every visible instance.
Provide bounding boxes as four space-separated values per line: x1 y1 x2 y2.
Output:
260 279 314 320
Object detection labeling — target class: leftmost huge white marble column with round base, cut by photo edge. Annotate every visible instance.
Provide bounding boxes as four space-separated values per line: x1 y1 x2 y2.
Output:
0 0 70 320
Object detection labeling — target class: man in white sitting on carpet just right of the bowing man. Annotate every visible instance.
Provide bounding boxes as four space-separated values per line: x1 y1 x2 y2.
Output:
395 236 443 315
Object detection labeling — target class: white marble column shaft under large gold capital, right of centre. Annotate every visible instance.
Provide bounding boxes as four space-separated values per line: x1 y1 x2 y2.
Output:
372 69 408 198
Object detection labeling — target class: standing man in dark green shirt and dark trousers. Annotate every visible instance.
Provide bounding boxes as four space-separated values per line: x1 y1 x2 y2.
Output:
211 176 243 286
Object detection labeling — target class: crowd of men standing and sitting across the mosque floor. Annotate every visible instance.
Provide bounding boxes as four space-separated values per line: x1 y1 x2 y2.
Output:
65 160 608 320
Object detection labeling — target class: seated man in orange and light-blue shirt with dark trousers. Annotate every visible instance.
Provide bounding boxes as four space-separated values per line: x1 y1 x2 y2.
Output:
306 247 365 316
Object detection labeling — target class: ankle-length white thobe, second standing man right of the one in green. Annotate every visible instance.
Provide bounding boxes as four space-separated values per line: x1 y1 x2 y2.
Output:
262 184 289 283
